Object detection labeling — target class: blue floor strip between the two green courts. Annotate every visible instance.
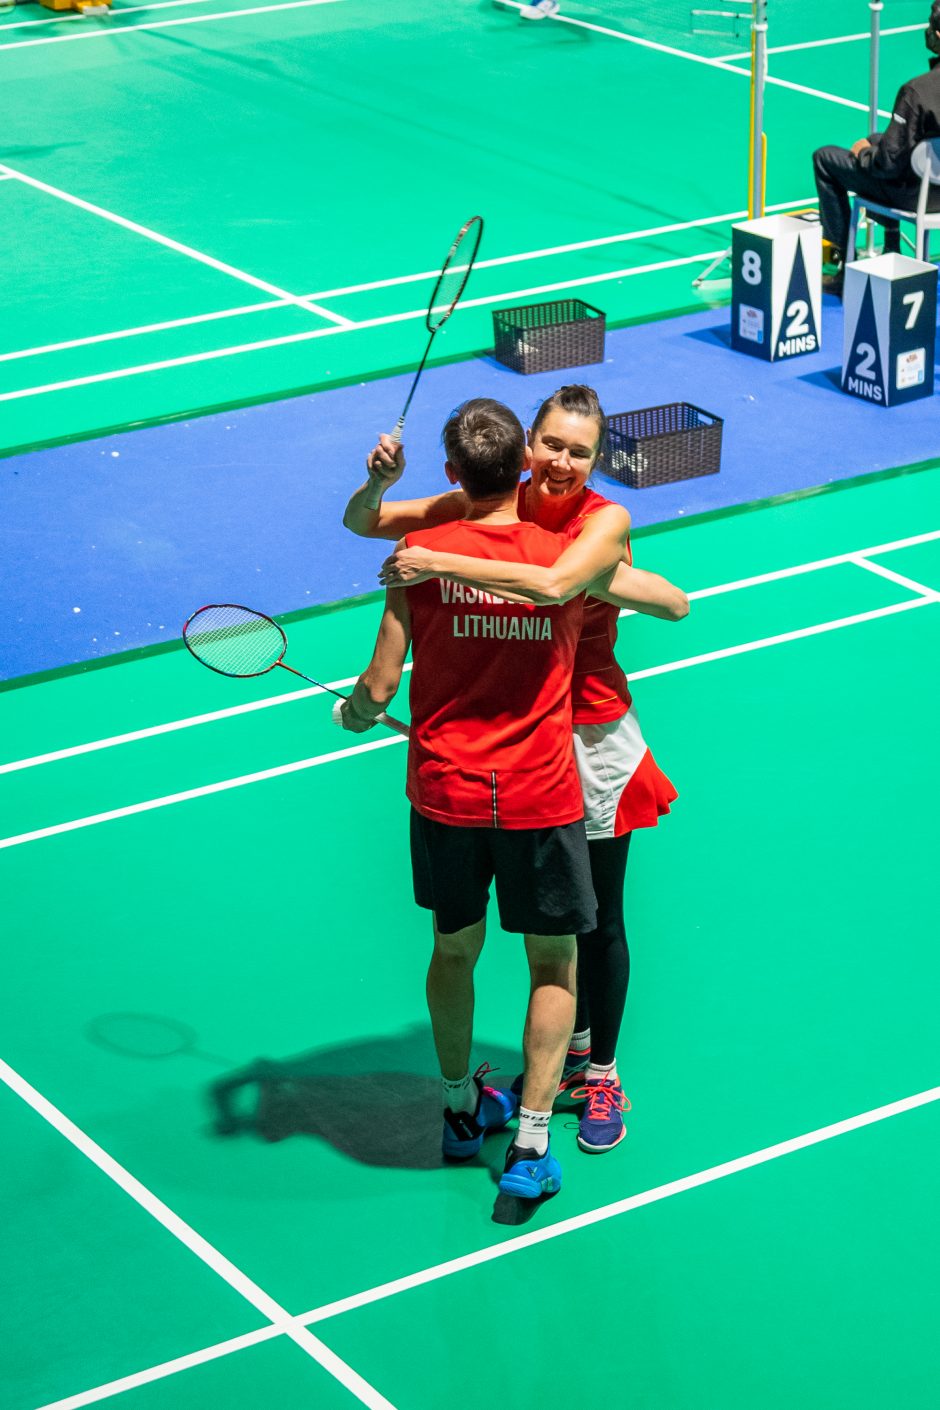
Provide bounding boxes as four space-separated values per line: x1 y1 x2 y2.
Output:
0 298 940 680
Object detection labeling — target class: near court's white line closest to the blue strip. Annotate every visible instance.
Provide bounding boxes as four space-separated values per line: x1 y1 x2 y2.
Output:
0 529 940 774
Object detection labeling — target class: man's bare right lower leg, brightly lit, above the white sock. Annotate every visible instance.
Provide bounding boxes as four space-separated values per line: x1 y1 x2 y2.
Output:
523 935 578 1111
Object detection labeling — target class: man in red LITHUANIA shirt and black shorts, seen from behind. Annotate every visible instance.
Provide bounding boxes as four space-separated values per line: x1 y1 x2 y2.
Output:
342 399 595 1199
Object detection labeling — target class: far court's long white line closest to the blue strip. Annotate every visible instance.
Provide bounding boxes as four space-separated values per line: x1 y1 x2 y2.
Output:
0 250 720 402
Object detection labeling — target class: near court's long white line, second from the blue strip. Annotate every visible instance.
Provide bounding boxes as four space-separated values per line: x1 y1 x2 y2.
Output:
0 594 940 850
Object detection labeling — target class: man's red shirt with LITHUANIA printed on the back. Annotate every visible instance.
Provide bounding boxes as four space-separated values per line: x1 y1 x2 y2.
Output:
406 520 583 828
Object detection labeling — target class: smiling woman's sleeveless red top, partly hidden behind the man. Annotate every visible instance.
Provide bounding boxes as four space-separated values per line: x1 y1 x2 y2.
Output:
517 482 631 725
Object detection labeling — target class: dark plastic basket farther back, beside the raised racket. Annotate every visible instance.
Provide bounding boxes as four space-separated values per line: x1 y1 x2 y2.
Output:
493 299 606 372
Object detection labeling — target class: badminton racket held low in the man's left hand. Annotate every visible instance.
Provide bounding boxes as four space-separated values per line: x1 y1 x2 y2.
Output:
183 602 409 737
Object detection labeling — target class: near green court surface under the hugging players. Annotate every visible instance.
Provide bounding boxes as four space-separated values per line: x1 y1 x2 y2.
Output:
0 465 940 1410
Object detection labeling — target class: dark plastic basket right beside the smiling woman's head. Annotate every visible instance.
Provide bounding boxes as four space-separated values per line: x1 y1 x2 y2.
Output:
602 402 724 489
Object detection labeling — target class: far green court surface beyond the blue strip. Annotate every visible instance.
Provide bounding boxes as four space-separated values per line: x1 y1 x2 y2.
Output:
0 0 924 453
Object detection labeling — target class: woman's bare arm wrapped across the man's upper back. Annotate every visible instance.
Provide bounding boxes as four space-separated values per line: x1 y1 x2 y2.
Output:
379 505 630 606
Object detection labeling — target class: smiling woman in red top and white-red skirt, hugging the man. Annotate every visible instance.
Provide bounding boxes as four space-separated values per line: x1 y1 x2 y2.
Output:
345 386 689 1153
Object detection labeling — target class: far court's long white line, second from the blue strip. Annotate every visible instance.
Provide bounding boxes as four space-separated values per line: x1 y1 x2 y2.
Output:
0 201 817 362
